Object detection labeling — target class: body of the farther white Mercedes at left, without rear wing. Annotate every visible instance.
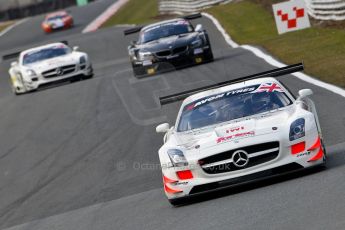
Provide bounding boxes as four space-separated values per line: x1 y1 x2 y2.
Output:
9 43 93 94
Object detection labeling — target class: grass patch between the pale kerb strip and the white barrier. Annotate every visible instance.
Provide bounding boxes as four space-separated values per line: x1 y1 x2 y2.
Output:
102 0 158 27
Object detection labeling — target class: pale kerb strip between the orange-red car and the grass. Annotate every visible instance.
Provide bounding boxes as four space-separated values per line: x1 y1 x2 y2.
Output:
83 0 129 33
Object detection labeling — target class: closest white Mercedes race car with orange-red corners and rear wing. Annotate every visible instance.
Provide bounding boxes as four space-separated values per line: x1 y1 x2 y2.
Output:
156 64 326 205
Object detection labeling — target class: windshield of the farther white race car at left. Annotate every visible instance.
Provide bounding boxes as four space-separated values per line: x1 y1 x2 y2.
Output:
23 46 71 65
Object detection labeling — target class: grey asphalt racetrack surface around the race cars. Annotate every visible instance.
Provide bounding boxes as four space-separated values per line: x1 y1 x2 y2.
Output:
0 2 345 230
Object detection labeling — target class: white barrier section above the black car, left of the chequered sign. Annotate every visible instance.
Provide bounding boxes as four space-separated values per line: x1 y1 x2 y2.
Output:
159 0 231 14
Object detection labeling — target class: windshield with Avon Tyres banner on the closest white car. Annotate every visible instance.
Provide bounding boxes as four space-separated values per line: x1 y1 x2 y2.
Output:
177 84 292 132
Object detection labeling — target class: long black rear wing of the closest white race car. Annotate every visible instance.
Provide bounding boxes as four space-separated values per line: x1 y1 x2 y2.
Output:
159 63 304 105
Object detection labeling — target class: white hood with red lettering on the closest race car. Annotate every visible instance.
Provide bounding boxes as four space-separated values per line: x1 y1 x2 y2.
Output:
173 109 293 155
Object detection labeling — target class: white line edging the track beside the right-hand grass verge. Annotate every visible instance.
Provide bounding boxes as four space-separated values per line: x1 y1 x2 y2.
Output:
202 13 345 97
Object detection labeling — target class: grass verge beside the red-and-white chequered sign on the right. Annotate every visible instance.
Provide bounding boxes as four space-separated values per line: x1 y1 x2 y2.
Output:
208 1 345 87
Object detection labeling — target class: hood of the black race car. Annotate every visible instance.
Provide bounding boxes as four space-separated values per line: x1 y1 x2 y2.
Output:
138 33 198 53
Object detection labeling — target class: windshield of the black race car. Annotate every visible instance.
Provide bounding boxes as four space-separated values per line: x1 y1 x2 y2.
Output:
139 21 193 44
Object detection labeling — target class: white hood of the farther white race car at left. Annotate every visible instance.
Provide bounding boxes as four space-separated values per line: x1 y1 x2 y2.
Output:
25 55 79 73
